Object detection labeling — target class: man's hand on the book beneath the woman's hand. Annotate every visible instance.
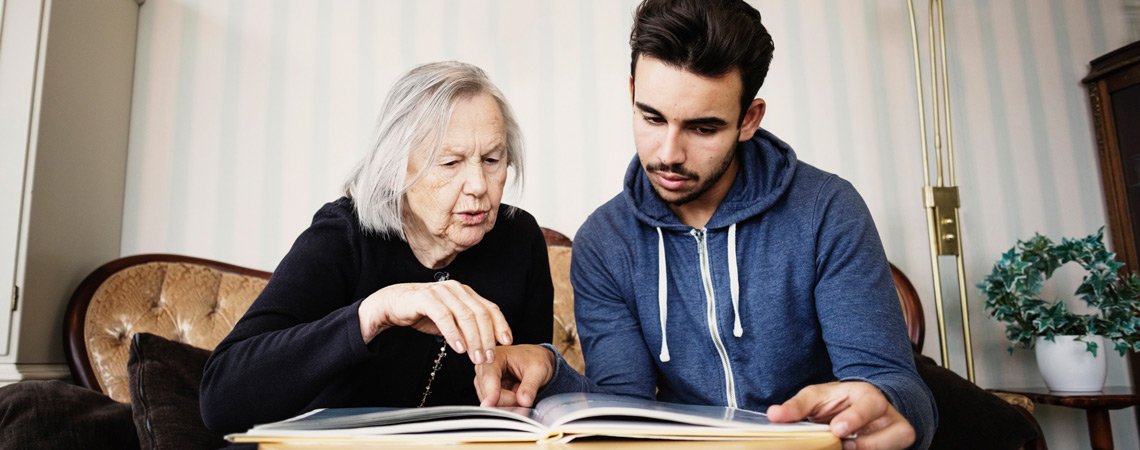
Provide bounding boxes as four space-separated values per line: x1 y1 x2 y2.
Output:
475 345 555 408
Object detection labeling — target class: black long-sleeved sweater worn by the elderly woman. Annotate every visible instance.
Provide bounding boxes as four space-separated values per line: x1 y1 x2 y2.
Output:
201 198 554 433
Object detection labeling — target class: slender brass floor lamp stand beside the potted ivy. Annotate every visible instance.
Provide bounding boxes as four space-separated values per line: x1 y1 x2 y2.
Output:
906 0 975 383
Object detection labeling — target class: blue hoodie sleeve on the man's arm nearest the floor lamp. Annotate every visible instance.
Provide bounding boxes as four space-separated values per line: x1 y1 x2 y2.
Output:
814 177 937 449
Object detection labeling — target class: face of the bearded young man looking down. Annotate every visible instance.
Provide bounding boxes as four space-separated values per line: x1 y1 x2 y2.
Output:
630 56 763 207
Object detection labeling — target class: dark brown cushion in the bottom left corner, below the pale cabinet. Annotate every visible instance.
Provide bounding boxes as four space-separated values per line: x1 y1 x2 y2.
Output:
0 381 139 450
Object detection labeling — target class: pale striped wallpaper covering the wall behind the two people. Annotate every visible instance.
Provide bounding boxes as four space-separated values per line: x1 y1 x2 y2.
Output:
122 0 1140 448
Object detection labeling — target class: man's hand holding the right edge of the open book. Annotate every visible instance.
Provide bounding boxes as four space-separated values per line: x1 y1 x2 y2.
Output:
768 382 914 450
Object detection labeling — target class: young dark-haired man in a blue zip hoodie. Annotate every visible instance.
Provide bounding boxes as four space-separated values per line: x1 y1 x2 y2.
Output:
475 0 936 449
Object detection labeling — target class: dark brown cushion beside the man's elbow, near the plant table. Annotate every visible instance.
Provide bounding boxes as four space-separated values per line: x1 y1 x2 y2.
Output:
914 353 1037 450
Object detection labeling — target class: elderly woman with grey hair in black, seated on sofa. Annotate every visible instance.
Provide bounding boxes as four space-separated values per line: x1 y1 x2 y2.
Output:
202 63 553 433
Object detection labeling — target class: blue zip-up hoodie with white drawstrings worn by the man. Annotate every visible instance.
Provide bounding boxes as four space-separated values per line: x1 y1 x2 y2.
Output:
540 130 937 448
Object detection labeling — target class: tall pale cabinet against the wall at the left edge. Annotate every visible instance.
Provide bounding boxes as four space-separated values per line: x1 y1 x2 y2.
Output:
0 0 139 385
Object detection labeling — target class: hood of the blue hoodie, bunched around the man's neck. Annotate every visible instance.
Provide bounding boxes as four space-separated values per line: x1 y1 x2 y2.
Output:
621 129 797 230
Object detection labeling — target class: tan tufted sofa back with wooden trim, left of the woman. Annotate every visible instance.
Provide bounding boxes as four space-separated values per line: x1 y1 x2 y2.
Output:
64 254 269 402
